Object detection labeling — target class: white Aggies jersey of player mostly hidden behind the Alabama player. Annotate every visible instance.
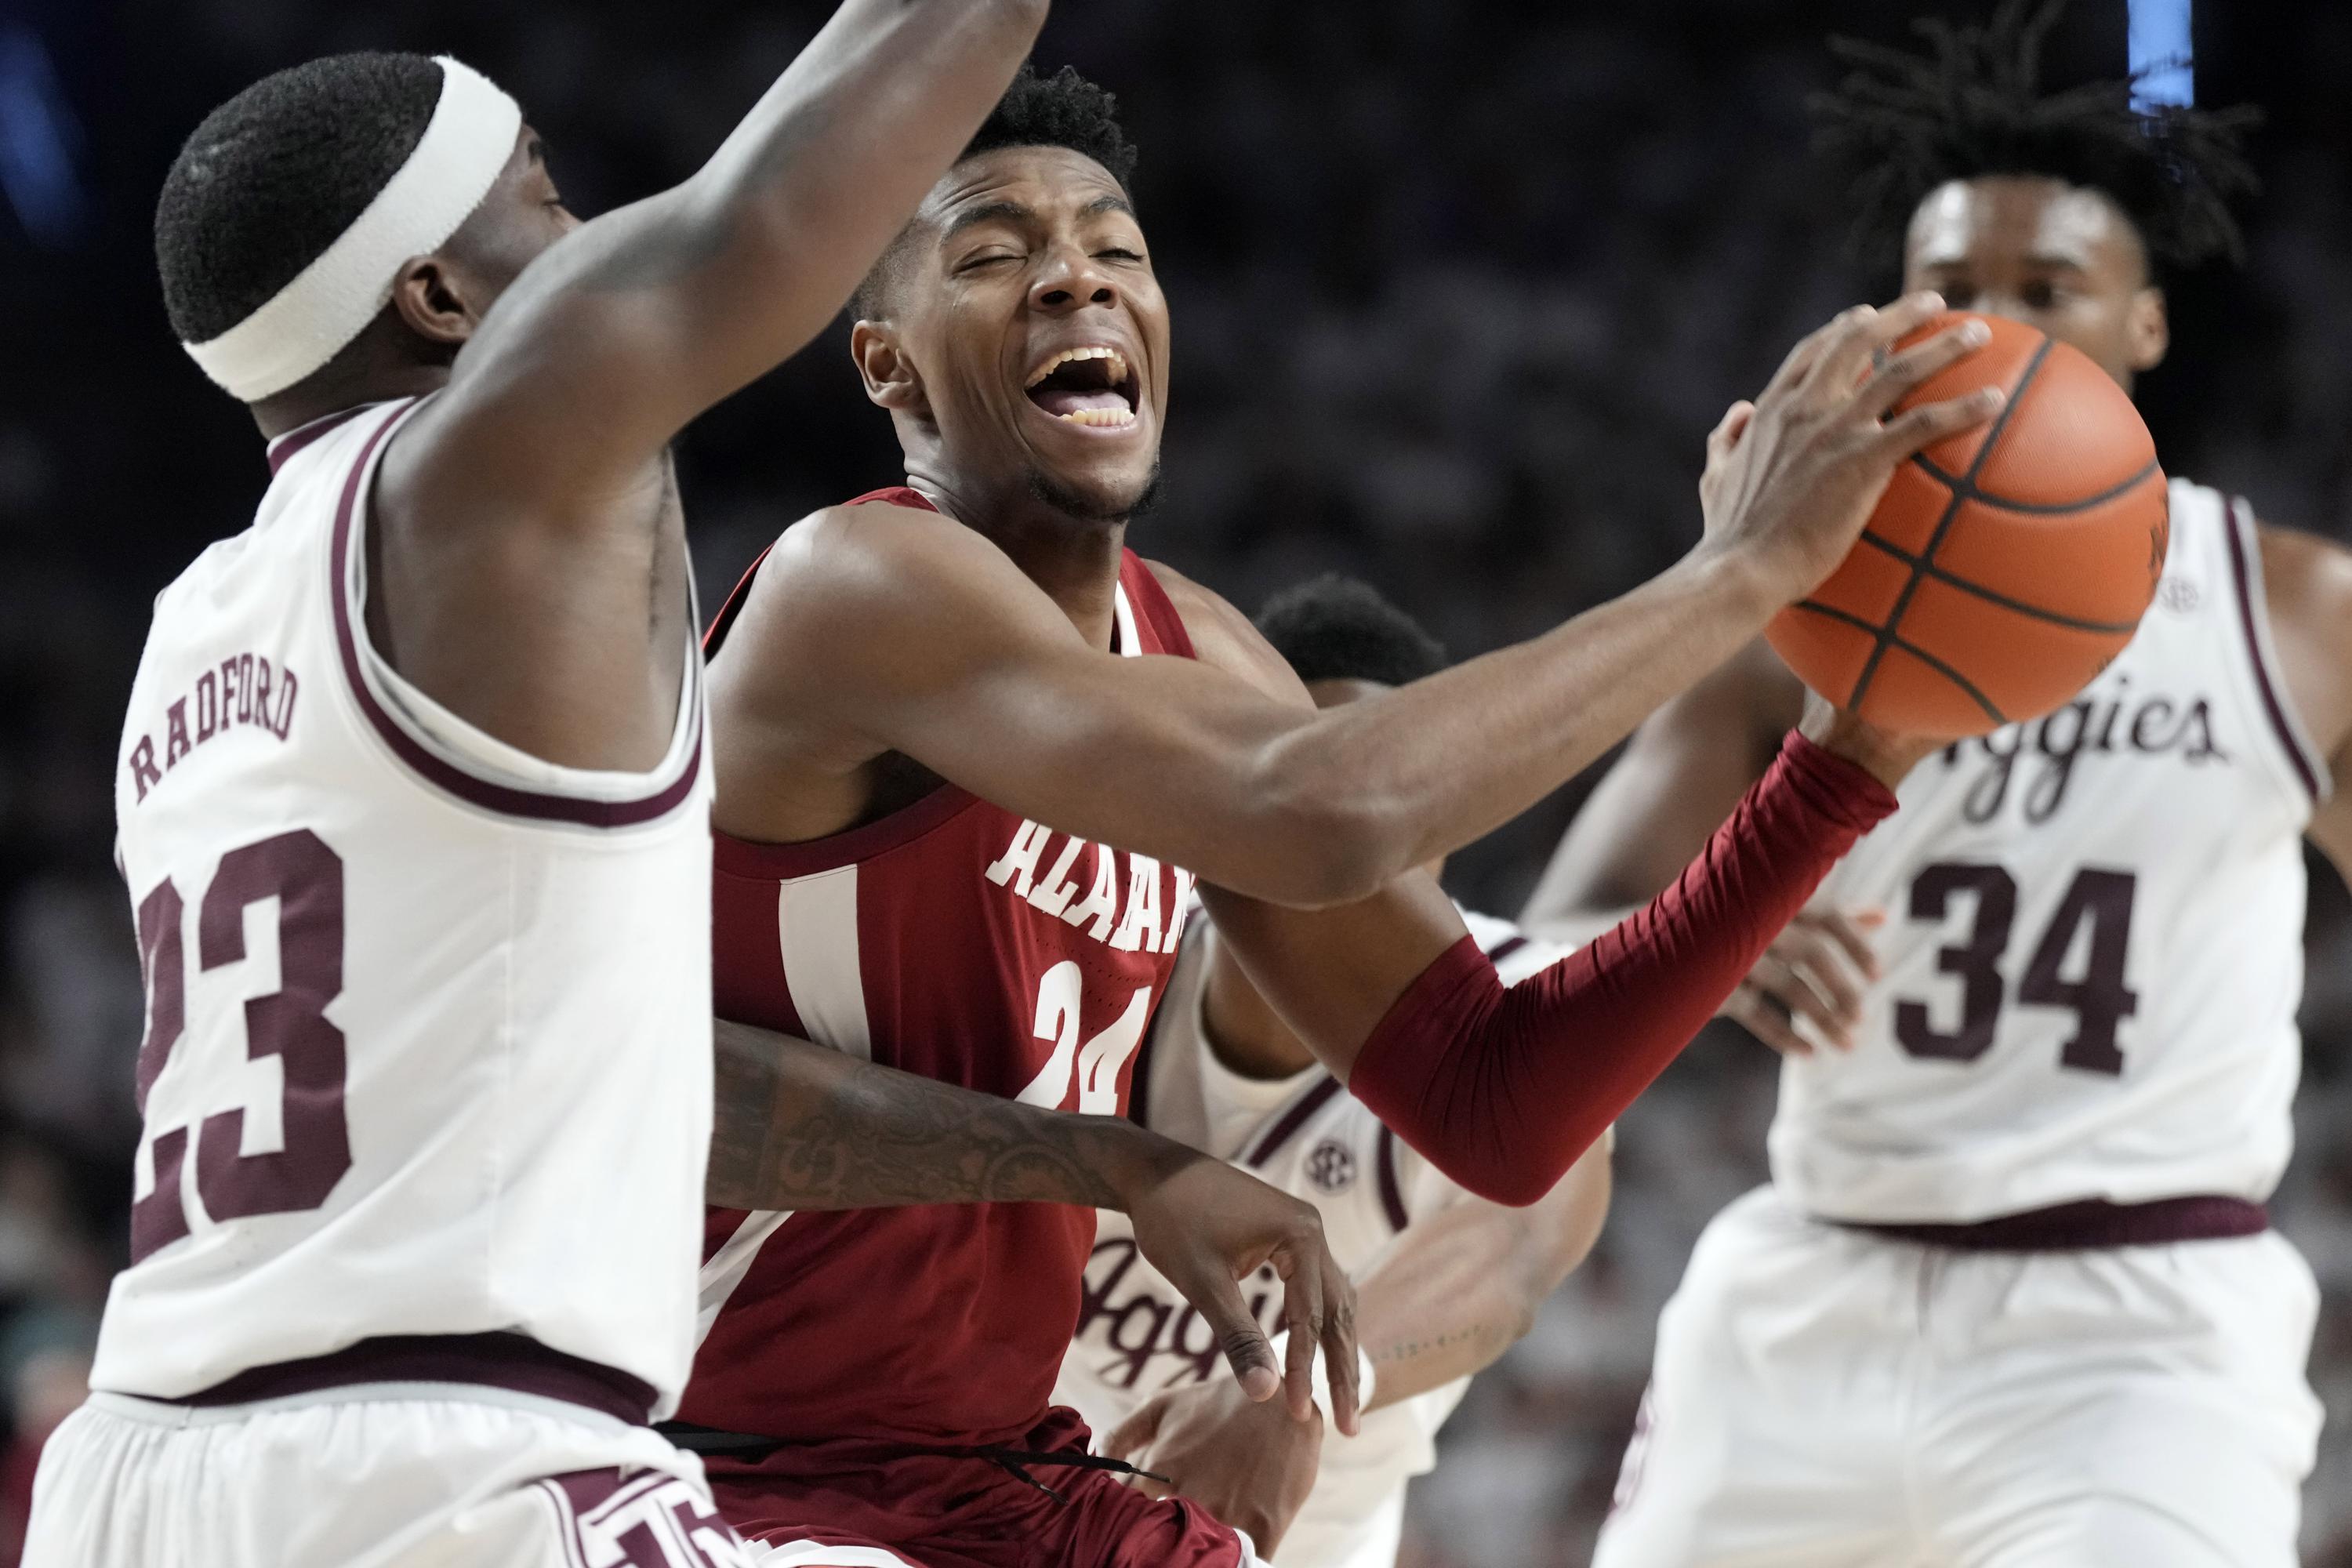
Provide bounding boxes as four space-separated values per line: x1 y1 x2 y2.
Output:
1054 912 1566 1568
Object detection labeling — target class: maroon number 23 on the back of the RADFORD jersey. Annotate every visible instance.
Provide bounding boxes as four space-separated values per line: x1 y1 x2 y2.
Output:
132 827 350 1262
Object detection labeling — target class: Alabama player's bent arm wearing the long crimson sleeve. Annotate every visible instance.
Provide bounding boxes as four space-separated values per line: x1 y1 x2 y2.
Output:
1190 590 1933 1203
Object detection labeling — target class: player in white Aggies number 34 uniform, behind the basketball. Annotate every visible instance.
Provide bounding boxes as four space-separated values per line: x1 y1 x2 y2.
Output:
1529 5 2352 1568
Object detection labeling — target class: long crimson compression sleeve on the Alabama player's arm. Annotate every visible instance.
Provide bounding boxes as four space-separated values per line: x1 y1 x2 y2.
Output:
1348 734 1896 1203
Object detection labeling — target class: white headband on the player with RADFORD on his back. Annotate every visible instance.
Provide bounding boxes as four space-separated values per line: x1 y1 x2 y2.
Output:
181 56 522 402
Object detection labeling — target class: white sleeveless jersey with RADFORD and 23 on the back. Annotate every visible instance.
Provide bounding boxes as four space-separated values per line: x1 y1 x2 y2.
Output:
92 402 710 1410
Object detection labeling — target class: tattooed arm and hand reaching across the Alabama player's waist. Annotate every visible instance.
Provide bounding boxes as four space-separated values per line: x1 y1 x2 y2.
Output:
703 1018 1357 1429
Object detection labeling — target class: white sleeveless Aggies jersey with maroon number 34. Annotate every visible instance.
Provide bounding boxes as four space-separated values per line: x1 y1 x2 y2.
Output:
1771 480 2328 1222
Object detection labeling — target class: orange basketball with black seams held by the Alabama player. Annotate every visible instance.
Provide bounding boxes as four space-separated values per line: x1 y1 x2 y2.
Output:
1766 315 2171 739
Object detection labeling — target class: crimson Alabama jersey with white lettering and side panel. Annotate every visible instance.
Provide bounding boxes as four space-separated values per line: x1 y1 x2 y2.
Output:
680 489 1192 1443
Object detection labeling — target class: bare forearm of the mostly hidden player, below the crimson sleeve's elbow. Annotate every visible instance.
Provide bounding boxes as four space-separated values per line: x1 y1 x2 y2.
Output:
1355 1147 1609 1410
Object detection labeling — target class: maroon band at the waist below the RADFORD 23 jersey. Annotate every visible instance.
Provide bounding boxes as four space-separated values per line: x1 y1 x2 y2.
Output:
162 1333 654 1427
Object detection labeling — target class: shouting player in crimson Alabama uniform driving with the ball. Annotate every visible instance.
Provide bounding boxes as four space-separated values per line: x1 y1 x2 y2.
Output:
682 73 1999 1563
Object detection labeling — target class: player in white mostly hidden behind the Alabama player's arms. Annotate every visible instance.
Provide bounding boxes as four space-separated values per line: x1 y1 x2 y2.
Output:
1054 576 1609 1568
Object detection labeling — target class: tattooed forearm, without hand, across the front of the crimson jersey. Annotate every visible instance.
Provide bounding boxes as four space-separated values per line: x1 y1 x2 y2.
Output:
706 1018 1171 1208
